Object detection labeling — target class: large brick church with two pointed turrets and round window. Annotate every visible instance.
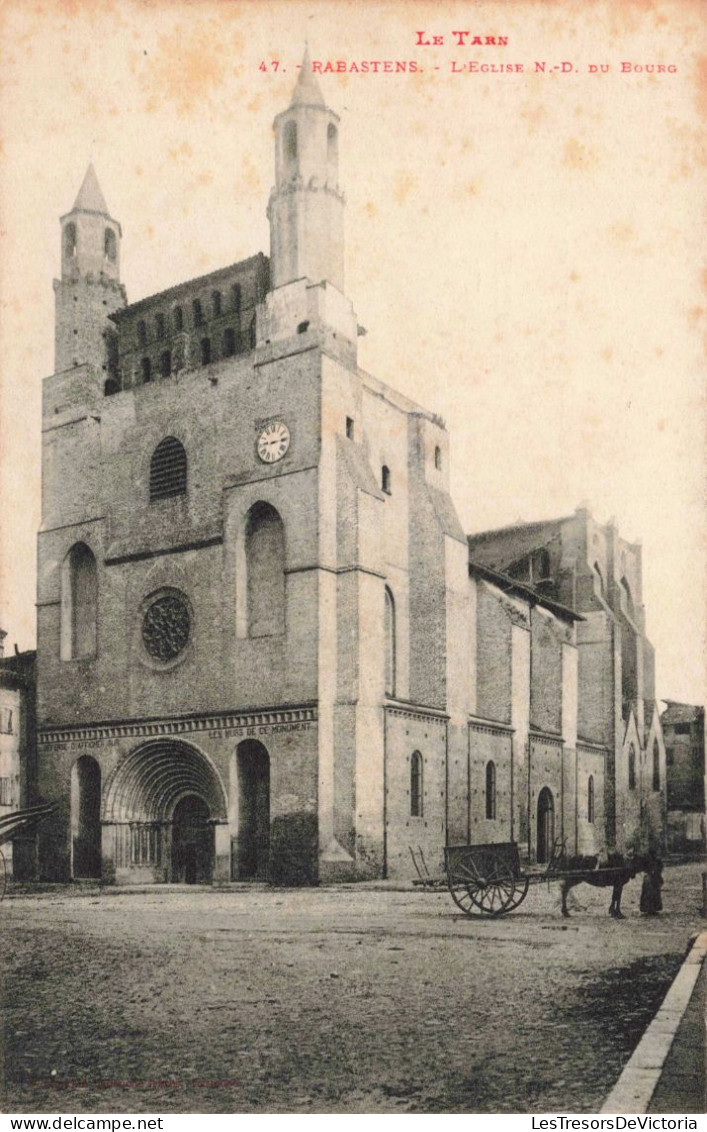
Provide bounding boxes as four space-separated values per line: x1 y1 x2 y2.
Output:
37 60 665 883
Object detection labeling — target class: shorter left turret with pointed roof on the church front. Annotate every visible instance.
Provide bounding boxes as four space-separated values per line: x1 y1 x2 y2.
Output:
54 165 126 377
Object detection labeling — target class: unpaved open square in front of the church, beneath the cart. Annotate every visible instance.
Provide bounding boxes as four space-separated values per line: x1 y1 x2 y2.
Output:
0 866 704 1113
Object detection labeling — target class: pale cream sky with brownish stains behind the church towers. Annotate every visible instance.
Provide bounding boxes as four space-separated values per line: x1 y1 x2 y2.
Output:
0 0 707 703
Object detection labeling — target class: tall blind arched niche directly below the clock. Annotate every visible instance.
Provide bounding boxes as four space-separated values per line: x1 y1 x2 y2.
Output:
245 503 285 637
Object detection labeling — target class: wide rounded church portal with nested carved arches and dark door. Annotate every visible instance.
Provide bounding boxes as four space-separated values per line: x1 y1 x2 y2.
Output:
103 739 226 884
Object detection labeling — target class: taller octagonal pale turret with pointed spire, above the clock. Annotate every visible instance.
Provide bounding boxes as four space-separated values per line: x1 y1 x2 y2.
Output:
268 49 344 292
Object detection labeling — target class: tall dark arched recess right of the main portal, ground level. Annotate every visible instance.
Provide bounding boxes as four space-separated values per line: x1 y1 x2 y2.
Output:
236 739 270 881
